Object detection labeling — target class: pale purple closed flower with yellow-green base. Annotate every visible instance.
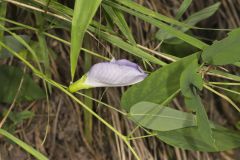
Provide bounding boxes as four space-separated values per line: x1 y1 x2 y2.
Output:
69 59 147 92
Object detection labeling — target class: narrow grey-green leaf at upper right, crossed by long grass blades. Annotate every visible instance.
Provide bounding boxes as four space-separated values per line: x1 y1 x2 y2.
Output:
156 2 221 43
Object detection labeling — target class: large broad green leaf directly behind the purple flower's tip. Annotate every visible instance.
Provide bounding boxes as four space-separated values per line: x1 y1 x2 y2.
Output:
121 54 197 111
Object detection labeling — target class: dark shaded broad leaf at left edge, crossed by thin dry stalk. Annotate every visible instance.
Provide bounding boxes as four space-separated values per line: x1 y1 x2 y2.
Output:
0 65 45 103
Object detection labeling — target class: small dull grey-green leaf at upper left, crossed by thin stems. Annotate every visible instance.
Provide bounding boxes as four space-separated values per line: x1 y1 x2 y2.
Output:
0 35 30 58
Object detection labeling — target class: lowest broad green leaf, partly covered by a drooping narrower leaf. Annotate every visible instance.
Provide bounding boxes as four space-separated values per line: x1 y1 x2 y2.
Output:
157 127 240 152
